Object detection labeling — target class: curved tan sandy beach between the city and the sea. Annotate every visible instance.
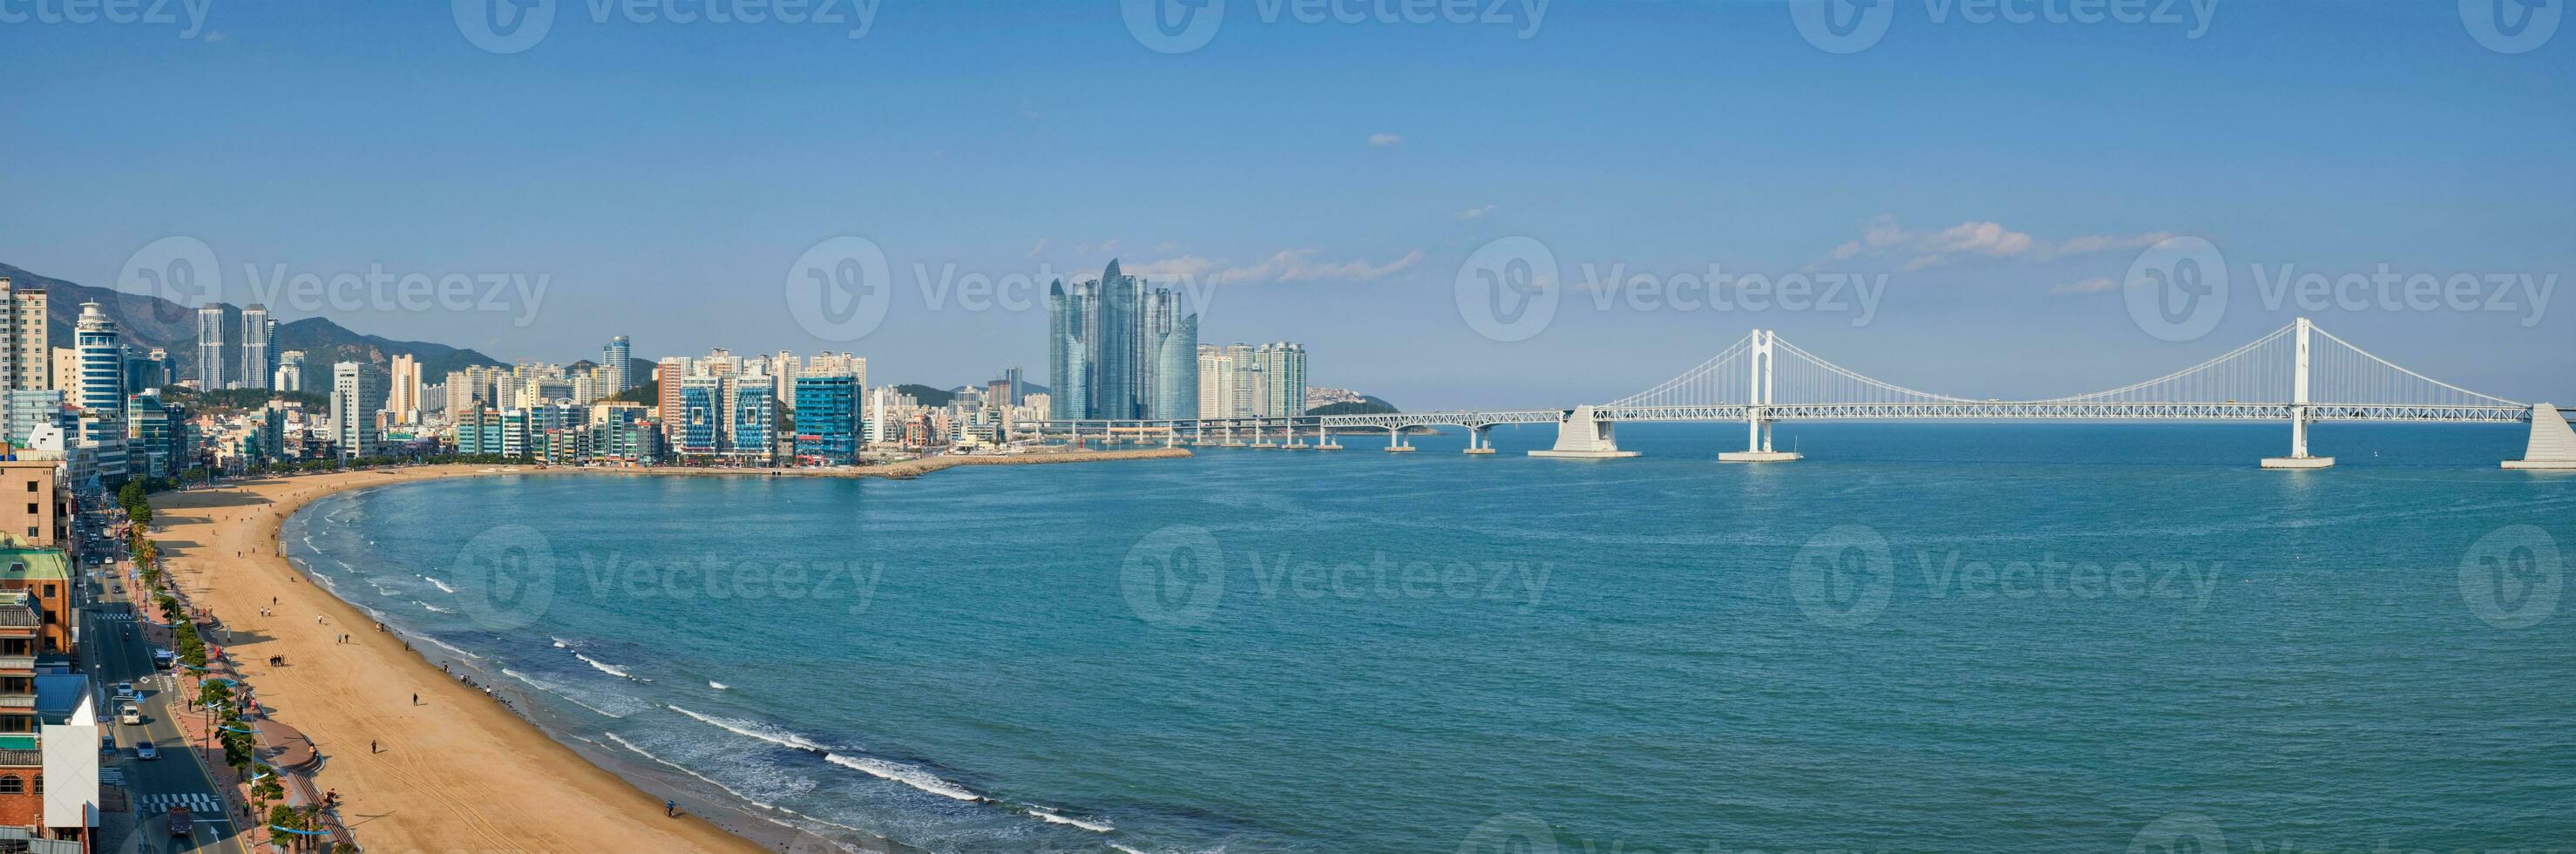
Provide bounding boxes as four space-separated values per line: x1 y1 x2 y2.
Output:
152 448 1188 851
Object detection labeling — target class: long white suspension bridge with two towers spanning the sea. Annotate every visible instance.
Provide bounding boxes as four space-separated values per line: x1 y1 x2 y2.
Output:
1023 319 2576 468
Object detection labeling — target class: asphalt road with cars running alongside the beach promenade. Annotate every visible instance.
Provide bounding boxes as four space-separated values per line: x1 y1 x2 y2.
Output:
80 550 242 854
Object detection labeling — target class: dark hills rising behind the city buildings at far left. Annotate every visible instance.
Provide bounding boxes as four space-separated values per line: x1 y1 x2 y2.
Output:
0 265 505 380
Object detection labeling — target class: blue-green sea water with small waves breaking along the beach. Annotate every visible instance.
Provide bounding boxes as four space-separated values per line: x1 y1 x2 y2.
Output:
286 424 2576 854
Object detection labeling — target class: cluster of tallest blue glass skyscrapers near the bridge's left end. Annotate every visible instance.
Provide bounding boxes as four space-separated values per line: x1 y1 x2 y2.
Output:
1046 260 1198 419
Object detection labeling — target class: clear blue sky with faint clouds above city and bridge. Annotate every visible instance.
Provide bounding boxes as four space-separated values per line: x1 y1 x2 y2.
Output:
0 0 2576 409
